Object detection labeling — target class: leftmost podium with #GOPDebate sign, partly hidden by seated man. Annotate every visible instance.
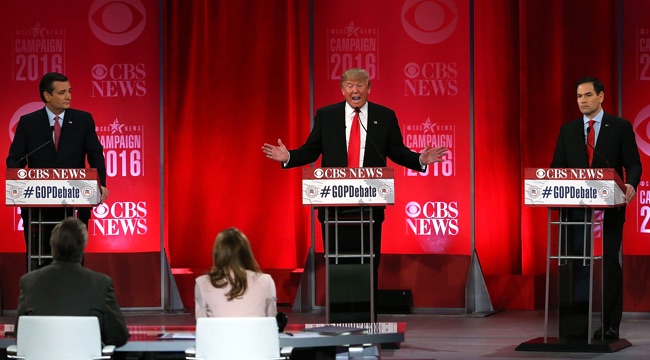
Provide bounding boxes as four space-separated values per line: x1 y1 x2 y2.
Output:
5 168 101 271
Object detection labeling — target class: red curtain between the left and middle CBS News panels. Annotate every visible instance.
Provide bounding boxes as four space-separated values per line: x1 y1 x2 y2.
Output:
164 0 310 270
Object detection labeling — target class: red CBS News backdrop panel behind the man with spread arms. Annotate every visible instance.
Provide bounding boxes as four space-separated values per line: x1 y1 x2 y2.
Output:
312 0 471 256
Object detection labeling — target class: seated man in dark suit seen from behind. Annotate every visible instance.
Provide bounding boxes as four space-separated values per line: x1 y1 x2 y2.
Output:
16 217 129 346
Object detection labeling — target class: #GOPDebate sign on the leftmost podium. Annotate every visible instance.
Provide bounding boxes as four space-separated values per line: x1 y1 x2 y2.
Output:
5 169 99 207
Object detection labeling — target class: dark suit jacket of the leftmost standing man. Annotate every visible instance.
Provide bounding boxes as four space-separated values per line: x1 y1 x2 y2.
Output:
7 107 106 186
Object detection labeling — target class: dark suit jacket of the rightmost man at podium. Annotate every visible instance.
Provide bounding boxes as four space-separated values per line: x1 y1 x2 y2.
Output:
551 113 641 224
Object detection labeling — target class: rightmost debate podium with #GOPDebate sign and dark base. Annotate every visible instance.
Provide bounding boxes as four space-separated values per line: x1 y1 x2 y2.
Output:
516 168 631 352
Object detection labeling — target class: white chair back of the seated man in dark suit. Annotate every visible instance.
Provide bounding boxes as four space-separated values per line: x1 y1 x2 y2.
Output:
16 316 102 360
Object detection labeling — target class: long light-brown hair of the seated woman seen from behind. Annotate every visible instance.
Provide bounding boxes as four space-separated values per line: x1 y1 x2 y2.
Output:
208 228 261 300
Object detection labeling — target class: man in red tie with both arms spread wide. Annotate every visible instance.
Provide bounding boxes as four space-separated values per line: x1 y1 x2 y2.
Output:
262 69 447 312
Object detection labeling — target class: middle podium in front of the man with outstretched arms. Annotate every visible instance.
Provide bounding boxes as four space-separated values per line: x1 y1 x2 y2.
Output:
302 167 395 323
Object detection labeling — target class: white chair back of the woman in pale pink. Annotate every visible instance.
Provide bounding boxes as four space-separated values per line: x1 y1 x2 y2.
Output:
195 317 280 360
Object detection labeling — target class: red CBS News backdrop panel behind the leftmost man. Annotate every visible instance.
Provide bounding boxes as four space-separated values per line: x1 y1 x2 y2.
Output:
0 0 161 308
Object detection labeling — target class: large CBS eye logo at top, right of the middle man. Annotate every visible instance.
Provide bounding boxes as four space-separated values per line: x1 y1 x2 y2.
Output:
402 0 458 45
